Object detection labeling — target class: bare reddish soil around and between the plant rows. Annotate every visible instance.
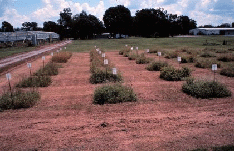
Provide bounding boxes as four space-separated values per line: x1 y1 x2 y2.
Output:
0 52 234 150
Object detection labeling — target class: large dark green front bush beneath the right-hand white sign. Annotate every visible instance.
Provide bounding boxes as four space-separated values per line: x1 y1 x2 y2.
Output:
182 79 231 99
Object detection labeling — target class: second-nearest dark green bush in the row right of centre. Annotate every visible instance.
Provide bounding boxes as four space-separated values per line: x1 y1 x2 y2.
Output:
160 67 191 81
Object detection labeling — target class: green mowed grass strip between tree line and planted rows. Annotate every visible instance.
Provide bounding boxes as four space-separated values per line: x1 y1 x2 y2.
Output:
65 36 234 52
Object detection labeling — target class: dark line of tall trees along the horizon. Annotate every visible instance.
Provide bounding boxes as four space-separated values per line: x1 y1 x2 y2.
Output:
0 5 201 39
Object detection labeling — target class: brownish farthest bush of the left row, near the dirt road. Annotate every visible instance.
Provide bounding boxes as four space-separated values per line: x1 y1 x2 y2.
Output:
52 51 72 63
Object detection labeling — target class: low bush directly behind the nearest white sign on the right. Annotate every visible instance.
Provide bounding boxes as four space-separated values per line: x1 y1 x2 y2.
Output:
195 59 221 68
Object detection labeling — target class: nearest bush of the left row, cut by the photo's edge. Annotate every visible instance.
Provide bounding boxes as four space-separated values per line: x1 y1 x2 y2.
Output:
0 91 40 110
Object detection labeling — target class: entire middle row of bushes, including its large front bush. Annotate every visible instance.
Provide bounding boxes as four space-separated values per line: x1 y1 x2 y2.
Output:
90 47 137 105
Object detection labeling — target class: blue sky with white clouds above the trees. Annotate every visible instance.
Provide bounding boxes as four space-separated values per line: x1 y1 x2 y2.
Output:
0 0 234 27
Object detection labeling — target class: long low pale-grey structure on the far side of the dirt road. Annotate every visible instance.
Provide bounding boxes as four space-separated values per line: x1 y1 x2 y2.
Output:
0 31 59 45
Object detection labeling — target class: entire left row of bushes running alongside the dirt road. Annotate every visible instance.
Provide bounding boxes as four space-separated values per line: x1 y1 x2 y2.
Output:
0 52 72 111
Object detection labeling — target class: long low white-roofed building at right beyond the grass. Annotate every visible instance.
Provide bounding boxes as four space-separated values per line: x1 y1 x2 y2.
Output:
189 28 234 35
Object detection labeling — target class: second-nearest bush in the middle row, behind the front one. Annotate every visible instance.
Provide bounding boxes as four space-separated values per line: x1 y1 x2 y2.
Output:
89 68 122 84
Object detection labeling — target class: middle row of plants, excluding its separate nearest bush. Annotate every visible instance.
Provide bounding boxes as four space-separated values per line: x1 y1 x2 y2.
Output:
89 50 122 84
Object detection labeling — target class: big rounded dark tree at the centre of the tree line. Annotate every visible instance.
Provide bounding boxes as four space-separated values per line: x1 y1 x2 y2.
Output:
103 5 132 34
